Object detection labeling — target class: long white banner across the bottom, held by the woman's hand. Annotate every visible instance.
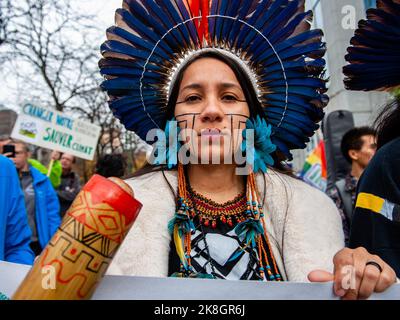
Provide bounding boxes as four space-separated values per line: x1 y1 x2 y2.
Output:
0 261 400 300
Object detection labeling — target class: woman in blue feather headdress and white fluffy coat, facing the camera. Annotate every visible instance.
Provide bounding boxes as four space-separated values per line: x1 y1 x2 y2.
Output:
100 0 396 299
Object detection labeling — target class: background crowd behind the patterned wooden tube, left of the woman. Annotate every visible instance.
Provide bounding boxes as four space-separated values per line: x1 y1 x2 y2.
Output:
0 136 126 264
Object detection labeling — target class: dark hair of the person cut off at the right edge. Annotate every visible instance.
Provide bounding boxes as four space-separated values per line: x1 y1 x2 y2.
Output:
374 97 400 149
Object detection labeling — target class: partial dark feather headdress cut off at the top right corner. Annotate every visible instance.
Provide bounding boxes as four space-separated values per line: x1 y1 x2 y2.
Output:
343 0 400 91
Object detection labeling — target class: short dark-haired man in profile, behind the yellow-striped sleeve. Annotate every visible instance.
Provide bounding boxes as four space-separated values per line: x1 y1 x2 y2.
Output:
327 127 376 246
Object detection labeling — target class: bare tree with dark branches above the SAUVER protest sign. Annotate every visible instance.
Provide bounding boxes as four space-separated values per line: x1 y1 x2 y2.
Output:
2 0 98 111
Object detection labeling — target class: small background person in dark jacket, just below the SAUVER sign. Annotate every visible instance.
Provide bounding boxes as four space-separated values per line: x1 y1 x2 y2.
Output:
56 153 81 217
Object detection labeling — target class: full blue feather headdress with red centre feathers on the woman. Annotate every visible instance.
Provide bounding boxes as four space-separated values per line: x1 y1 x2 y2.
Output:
99 0 328 159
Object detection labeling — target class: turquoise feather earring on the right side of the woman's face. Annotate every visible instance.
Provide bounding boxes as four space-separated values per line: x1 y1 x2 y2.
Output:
241 115 276 173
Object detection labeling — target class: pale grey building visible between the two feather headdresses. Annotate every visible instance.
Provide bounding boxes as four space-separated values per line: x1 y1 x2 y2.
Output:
292 0 389 171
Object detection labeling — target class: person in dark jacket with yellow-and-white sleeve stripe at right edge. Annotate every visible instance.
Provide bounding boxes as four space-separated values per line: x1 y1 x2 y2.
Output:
350 98 400 278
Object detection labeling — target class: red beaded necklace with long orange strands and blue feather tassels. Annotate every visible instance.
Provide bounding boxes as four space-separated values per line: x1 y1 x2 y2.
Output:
168 163 282 281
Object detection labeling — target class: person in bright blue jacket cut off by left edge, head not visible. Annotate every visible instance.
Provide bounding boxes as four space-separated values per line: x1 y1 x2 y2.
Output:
0 155 34 264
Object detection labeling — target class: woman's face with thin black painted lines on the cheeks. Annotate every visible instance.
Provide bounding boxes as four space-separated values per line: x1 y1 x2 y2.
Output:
175 58 250 163
